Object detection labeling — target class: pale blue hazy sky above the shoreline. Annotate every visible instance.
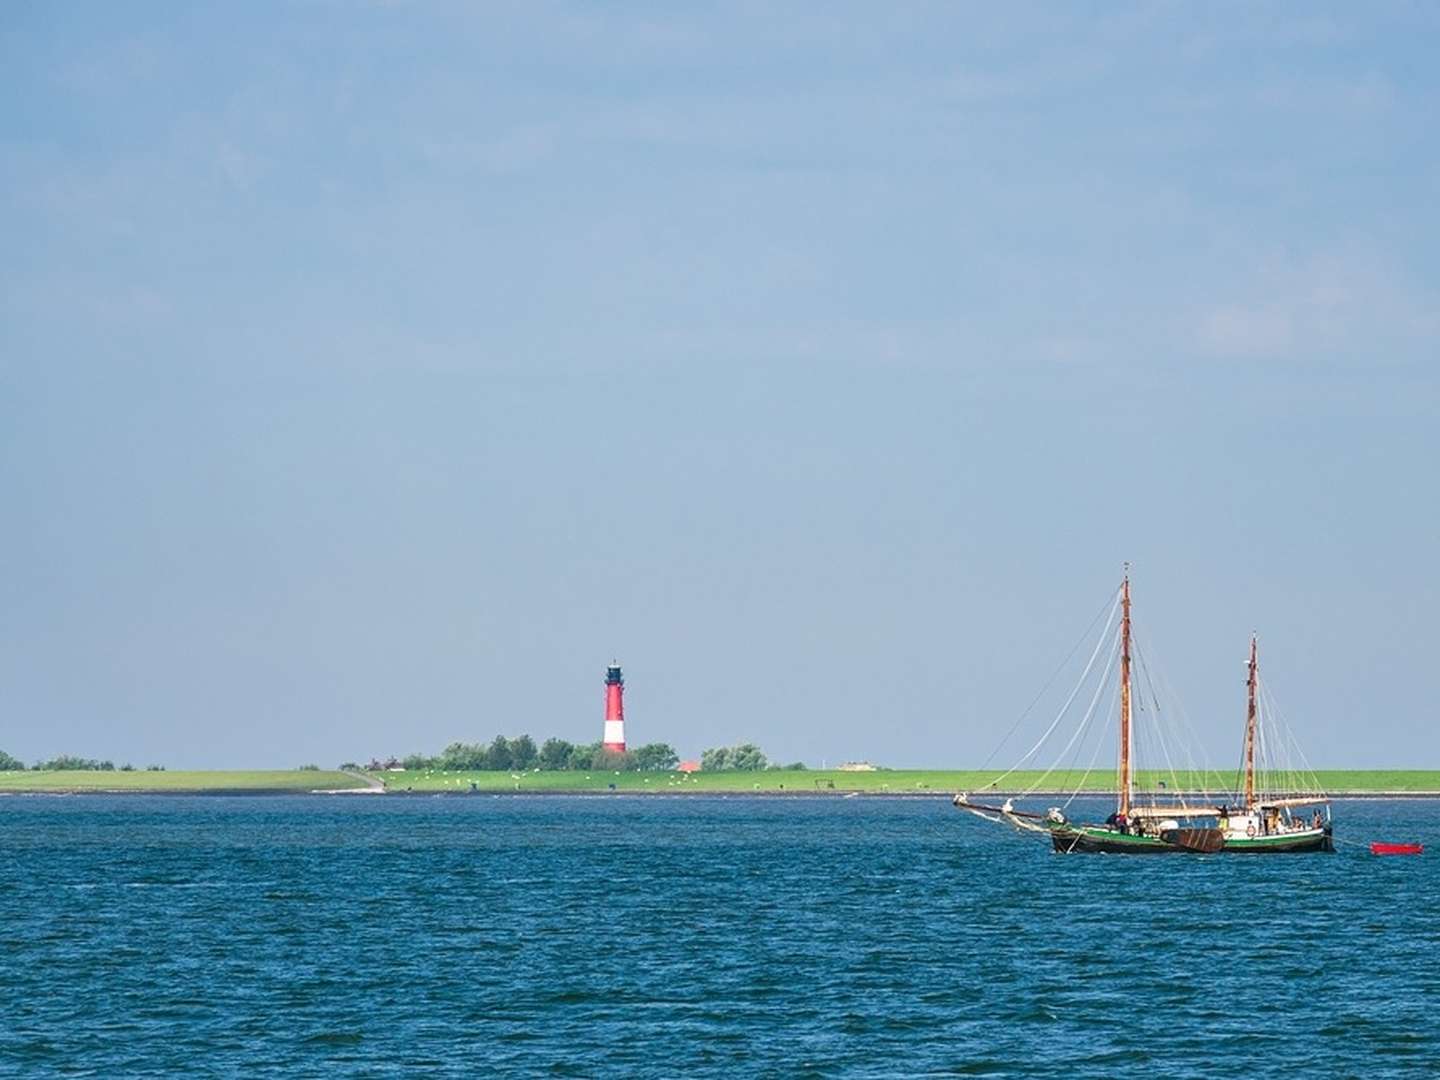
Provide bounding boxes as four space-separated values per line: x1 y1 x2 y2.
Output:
0 0 1440 768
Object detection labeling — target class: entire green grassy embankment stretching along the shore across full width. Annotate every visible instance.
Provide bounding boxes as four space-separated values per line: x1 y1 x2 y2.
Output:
0 769 1440 798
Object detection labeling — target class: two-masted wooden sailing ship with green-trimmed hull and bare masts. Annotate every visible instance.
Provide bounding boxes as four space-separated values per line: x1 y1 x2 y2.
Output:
953 573 1335 854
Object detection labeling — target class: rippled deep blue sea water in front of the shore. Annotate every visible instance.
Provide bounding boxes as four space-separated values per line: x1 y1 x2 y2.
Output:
0 796 1440 1077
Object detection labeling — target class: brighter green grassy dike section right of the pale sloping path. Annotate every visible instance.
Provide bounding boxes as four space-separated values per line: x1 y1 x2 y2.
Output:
365 769 1440 796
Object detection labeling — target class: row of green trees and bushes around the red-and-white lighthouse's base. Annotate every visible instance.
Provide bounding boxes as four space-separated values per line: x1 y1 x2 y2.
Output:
340 734 805 772
